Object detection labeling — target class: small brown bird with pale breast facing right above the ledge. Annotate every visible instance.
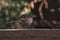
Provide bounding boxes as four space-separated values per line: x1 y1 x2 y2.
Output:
9 14 35 28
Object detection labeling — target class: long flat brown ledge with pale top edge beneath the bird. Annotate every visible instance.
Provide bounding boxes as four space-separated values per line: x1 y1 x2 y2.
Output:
0 29 60 40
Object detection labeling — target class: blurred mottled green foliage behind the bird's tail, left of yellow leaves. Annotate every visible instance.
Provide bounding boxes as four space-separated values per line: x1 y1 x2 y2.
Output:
0 0 31 29
